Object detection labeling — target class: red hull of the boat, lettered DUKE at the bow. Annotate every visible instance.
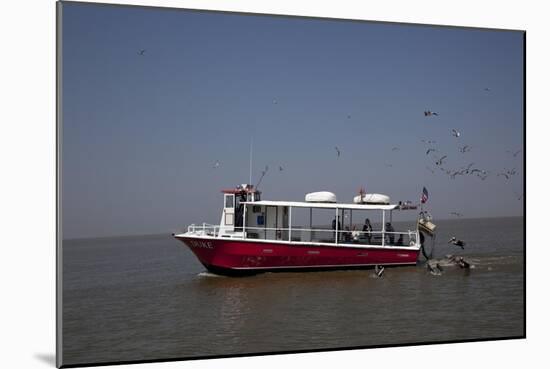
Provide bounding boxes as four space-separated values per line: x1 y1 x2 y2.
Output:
175 236 419 275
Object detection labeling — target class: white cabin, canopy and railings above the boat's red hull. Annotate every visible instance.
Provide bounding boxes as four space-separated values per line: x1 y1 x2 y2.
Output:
188 184 420 248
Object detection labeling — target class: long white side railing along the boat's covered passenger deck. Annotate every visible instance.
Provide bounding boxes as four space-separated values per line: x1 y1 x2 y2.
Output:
244 227 417 247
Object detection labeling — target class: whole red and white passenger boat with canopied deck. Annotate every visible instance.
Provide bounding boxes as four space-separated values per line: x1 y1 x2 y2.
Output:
173 184 435 275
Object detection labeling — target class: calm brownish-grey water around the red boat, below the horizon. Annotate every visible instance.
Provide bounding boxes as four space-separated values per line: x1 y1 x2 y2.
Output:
63 217 525 365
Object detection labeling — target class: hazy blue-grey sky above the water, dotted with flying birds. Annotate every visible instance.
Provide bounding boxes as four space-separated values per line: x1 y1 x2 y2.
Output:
62 3 524 238
